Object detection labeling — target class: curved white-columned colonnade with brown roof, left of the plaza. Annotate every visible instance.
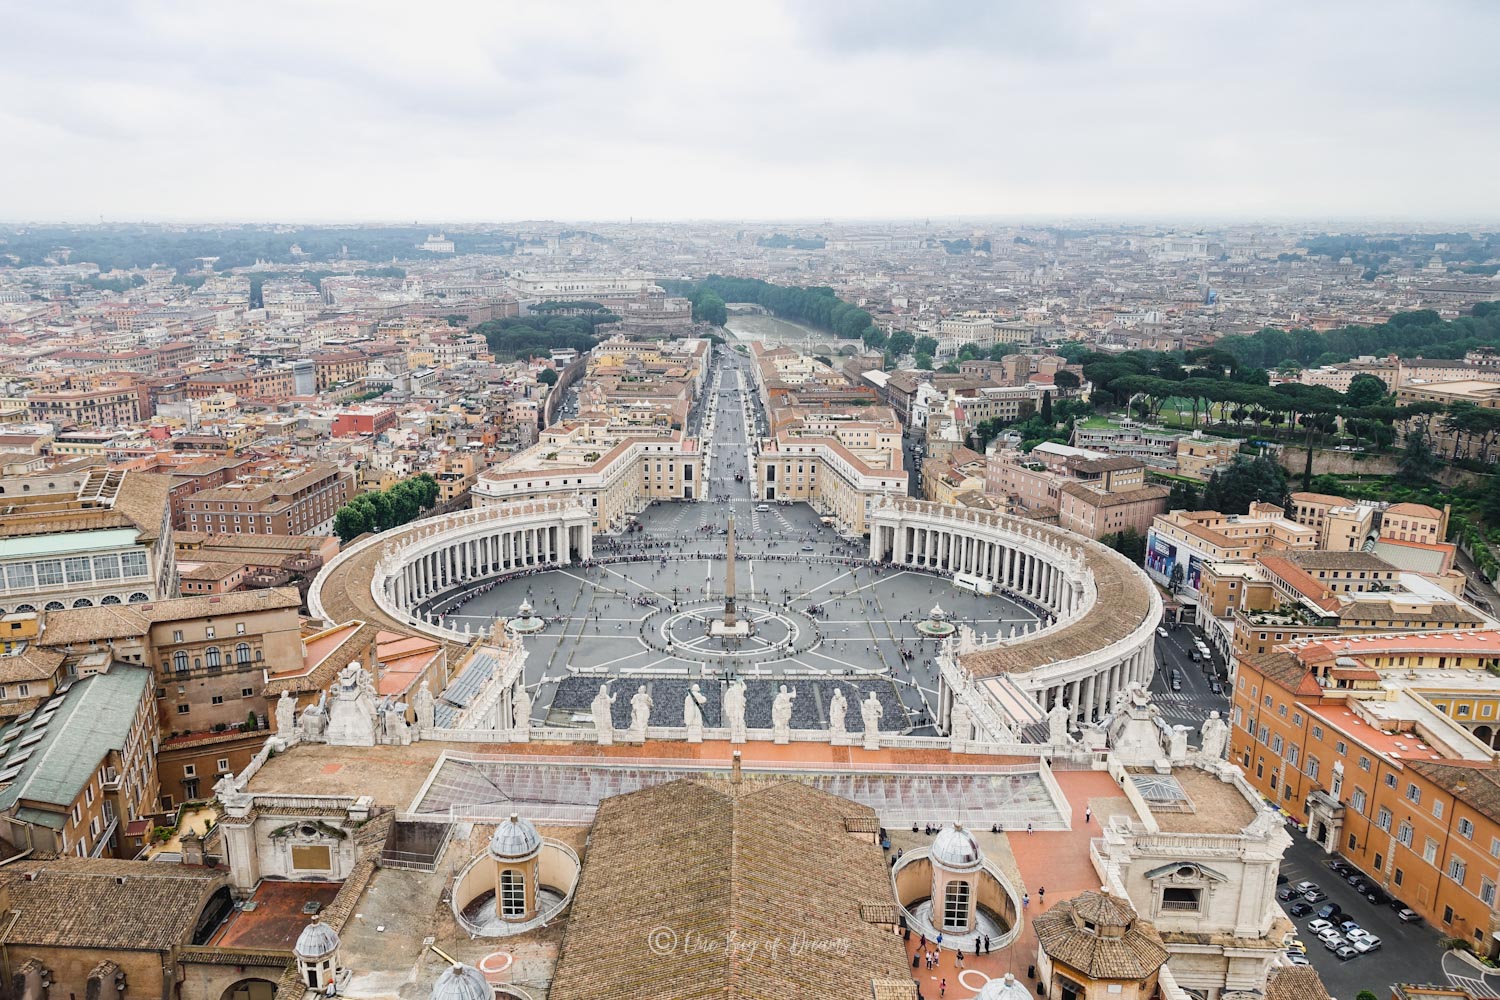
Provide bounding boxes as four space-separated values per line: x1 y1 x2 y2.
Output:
308 501 594 642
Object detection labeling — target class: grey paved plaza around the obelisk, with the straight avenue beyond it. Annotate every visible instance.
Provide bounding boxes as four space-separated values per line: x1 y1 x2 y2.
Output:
419 351 1040 735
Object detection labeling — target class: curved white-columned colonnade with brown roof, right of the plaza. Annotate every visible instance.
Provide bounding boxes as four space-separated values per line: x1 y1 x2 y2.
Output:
870 499 1161 741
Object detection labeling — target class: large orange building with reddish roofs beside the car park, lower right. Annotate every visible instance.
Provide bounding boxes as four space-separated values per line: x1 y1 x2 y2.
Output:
1230 630 1500 957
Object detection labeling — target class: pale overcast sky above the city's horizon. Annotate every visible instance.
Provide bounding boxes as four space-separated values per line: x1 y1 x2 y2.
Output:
0 0 1500 222
